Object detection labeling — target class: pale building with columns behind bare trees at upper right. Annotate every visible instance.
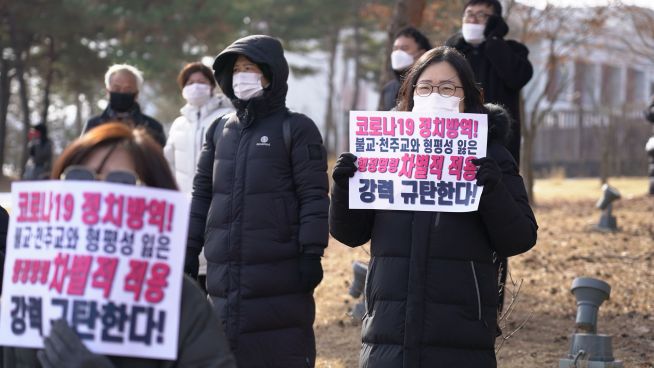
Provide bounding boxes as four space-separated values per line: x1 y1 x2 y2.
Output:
511 3 654 178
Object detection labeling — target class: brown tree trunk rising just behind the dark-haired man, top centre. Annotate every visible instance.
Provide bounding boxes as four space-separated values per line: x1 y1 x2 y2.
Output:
378 0 426 106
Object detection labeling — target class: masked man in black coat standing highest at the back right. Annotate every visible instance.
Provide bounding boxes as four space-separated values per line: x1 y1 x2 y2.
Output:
446 0 534 167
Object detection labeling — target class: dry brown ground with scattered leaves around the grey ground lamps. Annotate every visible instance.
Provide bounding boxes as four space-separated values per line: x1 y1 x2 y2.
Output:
315 179 654 368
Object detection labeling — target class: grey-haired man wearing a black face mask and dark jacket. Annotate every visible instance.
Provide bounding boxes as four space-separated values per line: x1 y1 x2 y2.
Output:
82 64 166 147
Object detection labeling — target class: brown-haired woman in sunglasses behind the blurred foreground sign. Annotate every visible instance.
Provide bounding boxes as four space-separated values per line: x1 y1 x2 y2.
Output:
2 122 236 368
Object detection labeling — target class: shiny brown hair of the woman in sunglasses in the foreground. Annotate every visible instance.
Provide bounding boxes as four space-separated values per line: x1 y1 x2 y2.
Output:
51 122 177 189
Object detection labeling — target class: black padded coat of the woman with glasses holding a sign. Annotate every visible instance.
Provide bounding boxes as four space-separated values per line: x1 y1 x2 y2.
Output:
329 106 538 368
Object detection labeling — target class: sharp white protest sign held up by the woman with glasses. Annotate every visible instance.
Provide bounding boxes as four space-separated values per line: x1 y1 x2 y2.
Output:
349 111 488 212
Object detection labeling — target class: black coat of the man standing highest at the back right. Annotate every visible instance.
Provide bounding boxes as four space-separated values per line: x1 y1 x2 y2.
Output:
446 33 534 164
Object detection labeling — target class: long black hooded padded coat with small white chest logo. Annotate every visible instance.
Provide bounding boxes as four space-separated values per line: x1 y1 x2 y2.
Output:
187 36 329 368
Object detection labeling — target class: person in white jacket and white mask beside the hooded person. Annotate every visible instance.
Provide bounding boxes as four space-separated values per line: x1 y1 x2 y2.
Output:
164 62 234 291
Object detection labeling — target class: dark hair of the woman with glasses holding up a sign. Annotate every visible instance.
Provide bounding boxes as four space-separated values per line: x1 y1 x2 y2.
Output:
397 46 485 114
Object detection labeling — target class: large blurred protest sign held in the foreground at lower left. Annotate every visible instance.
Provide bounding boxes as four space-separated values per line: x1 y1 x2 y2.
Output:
0 181 189 360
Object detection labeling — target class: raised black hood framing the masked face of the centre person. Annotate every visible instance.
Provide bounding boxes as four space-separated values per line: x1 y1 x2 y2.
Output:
213 35 289 119
